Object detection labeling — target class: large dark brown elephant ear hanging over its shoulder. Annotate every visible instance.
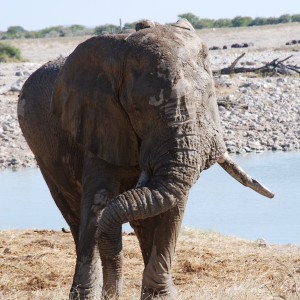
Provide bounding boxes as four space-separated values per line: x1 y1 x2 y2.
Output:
51 36 138 166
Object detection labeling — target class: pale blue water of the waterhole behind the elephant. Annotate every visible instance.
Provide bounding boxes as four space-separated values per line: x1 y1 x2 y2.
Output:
0 152 300 245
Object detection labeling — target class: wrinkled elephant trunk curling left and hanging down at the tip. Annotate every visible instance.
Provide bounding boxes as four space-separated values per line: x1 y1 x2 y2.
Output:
98 137 204 253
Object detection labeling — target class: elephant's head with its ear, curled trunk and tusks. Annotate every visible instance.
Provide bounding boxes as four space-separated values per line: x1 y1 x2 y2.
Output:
52 21 272 298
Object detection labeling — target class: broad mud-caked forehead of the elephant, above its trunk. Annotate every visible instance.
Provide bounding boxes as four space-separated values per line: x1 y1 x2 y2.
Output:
124 26 212 126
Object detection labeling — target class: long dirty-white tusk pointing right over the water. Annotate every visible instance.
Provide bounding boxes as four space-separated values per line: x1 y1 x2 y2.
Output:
218 152 274 198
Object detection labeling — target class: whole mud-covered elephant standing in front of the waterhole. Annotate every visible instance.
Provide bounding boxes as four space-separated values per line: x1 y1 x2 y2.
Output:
18 20 274 300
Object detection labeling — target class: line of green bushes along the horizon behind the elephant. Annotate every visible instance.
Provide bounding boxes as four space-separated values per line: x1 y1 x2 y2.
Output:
0 13 300 40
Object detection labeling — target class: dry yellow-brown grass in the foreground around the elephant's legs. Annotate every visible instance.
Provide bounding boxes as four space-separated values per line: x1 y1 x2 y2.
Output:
0 230 300 300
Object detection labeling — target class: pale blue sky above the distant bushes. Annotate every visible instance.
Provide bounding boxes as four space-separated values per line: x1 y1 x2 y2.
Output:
0 0 300 31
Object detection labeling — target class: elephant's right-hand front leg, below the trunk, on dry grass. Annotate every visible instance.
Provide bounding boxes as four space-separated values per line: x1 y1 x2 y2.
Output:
131 203 184 300
